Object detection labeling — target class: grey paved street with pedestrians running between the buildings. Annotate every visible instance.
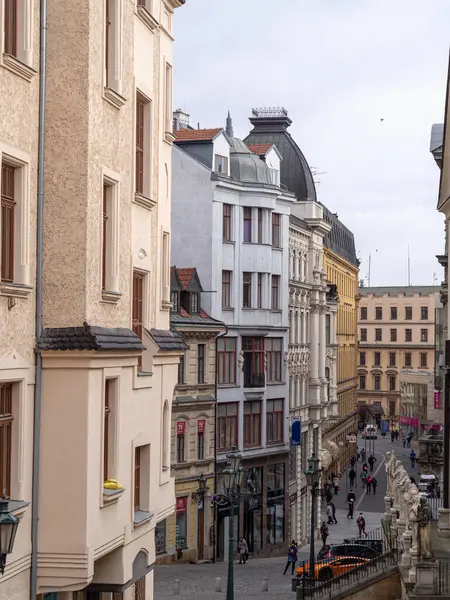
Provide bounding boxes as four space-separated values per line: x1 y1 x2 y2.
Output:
155 439 418 600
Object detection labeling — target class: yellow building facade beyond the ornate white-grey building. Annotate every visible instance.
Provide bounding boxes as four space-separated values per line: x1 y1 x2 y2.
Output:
324 248 359 417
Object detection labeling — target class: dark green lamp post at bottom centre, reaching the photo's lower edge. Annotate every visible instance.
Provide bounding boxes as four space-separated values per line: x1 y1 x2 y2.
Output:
213 449 251 600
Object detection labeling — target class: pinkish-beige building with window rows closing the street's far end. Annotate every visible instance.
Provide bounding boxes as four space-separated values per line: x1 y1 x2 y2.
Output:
358 286 440 427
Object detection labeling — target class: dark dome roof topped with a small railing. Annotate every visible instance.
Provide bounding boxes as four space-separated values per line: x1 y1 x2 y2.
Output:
244 108 317 201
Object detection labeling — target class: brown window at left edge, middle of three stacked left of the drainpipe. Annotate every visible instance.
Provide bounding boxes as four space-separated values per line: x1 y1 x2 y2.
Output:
0 162 16 283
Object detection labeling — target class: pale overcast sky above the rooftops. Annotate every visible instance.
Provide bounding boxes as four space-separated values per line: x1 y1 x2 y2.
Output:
174 0 450 285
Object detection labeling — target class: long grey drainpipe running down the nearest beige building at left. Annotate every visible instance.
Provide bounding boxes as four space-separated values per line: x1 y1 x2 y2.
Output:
30 0 47 600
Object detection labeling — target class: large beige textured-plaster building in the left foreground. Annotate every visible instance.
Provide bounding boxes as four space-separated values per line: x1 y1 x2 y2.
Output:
0 0 184 600
